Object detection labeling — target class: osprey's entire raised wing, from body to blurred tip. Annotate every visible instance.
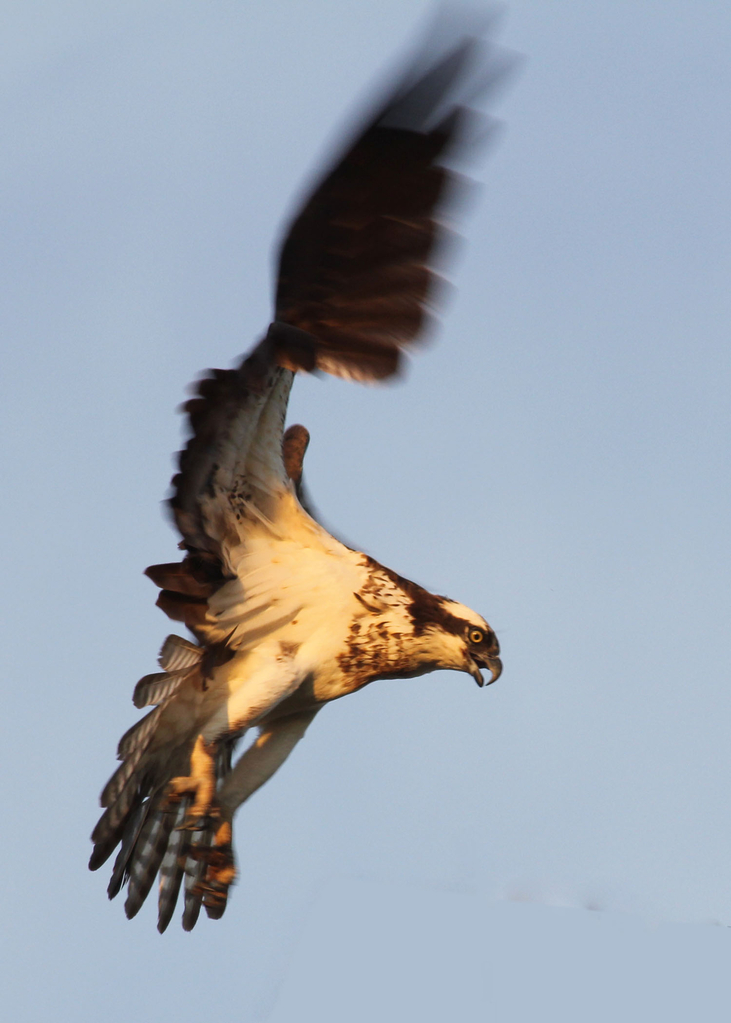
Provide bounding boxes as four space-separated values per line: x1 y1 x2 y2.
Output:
165 29 504 596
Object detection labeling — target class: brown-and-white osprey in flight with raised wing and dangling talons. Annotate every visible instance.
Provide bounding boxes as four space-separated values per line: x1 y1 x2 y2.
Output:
89 31 502 932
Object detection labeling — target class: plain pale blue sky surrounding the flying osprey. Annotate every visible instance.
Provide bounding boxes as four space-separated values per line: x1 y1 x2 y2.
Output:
0 0 731 1023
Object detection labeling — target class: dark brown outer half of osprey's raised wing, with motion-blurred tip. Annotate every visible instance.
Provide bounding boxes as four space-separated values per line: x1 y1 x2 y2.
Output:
275 39 495 381
